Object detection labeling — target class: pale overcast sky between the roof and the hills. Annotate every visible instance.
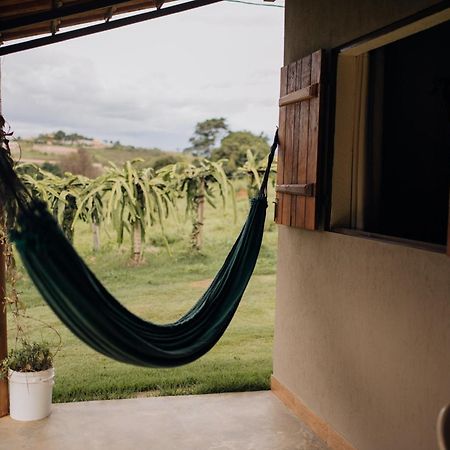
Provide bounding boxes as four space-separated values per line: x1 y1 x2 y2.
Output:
2 0 284 150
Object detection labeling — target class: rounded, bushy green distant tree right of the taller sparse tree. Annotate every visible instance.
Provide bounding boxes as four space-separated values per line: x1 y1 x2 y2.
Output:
211 131 269 175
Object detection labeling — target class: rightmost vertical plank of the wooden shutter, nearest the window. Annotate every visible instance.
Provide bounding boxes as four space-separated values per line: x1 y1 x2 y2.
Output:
305 51 323 230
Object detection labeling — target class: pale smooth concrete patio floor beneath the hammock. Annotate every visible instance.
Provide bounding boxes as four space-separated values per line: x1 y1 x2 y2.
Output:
0 391 328 450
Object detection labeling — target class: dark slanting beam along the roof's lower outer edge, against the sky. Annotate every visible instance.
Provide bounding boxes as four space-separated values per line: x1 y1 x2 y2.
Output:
0 0 222 56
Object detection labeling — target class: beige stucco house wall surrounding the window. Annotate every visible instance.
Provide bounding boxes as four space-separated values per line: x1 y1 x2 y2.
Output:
274 0 450 450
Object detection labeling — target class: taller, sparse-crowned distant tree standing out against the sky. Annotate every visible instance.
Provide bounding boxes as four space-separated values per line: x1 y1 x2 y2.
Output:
184 117 228 158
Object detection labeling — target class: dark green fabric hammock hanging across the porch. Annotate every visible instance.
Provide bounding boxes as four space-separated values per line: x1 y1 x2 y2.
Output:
0 129 278 367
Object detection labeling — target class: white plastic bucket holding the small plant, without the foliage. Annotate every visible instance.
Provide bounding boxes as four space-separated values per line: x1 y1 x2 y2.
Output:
9 368 55 421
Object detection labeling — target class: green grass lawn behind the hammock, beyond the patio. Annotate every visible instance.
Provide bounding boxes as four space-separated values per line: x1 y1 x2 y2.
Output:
9 188 276 402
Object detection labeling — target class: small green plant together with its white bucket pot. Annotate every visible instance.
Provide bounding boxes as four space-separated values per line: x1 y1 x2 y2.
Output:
0 341 54 421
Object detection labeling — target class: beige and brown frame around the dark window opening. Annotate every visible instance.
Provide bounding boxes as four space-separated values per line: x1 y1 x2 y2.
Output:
327 6 450 256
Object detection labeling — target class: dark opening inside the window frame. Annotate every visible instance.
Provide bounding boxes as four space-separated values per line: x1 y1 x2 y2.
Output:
363 22 450 245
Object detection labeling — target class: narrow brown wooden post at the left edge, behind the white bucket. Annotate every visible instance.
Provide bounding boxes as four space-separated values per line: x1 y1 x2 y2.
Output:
0 58 9 417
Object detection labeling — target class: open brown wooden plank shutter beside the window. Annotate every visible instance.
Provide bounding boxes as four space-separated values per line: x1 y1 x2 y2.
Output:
275 50 324 230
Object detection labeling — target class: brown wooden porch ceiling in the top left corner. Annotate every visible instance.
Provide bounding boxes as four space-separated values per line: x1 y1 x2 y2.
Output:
0 0 178 42
